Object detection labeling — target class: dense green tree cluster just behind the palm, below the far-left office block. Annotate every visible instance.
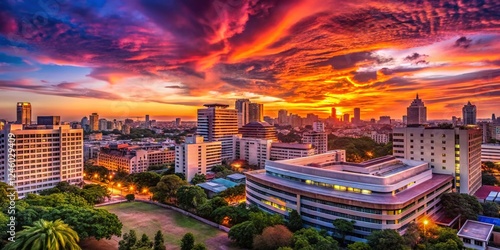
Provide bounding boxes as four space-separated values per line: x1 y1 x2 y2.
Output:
0 183 122 247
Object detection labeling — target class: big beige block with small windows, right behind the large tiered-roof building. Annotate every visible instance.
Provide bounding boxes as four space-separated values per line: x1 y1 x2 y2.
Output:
393 127 482 194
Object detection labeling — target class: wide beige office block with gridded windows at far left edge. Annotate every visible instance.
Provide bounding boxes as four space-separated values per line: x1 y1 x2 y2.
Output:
0 124 83 198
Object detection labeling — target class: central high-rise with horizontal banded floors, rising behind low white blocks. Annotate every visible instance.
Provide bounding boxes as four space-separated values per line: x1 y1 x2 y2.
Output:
197 104 238 161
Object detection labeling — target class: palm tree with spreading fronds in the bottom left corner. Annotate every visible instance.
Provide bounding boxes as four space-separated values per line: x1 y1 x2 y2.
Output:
5 219 81 250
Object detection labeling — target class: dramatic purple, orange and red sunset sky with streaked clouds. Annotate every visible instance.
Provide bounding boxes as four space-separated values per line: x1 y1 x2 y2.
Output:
0 0 500 120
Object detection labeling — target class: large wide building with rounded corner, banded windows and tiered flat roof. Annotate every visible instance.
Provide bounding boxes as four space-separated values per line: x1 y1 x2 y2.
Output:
246 153 453 241
